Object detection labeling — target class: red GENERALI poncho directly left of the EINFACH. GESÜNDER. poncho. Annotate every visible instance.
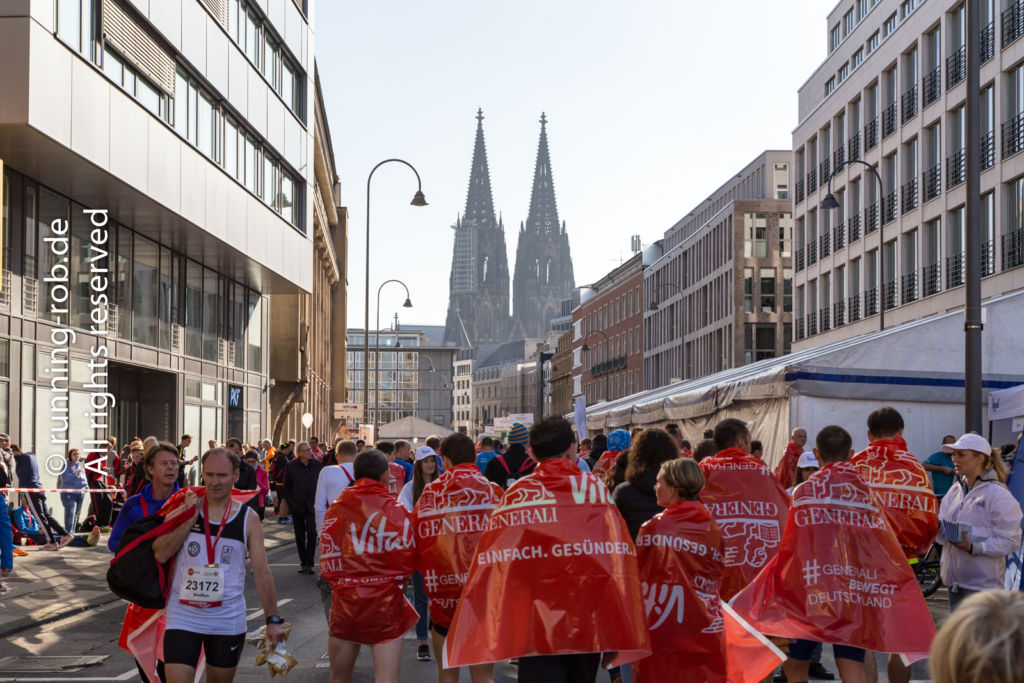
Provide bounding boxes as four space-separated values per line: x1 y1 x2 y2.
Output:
413 463 505 628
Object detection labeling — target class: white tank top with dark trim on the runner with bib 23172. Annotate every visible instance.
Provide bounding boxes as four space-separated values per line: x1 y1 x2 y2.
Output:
167 501 249 636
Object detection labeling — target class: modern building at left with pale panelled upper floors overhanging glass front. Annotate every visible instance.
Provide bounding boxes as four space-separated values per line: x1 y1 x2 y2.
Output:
0 0 313 455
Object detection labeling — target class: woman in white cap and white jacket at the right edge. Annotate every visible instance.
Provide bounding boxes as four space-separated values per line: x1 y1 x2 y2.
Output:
939 434 1022 611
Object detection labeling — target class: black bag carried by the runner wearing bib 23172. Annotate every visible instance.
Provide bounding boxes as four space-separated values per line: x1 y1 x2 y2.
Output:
106 514 188 609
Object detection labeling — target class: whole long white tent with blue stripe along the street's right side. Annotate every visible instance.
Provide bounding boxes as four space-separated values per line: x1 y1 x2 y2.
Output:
587 293 1024 471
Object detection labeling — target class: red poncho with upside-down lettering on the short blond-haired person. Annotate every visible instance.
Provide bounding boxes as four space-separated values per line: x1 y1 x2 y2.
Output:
633 501 726 683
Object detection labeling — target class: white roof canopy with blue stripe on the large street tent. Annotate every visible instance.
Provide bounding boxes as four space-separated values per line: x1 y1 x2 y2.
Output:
587 292 1024 430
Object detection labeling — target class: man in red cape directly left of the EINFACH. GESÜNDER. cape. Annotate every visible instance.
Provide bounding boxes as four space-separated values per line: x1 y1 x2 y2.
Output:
413 433 505 683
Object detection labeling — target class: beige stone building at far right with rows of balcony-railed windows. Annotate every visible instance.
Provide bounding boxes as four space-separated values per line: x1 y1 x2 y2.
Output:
793 0 1024 348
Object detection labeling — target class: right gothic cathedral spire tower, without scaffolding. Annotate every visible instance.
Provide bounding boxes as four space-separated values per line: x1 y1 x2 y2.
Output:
512 114 575 339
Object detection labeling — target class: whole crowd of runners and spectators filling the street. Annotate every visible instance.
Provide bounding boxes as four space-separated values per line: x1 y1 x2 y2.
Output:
0 408 1024 683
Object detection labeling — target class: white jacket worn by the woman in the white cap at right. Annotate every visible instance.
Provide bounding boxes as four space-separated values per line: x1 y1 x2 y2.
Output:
938 470 1022 591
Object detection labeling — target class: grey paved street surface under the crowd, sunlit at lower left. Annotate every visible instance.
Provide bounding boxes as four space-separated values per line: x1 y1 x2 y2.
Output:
0 519 945 683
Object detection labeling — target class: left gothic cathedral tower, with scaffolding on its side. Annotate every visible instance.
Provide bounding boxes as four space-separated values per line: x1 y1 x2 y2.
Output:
444 110 511 347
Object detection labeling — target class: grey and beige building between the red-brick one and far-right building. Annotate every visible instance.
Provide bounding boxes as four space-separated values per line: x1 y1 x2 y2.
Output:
642 151 793 389
